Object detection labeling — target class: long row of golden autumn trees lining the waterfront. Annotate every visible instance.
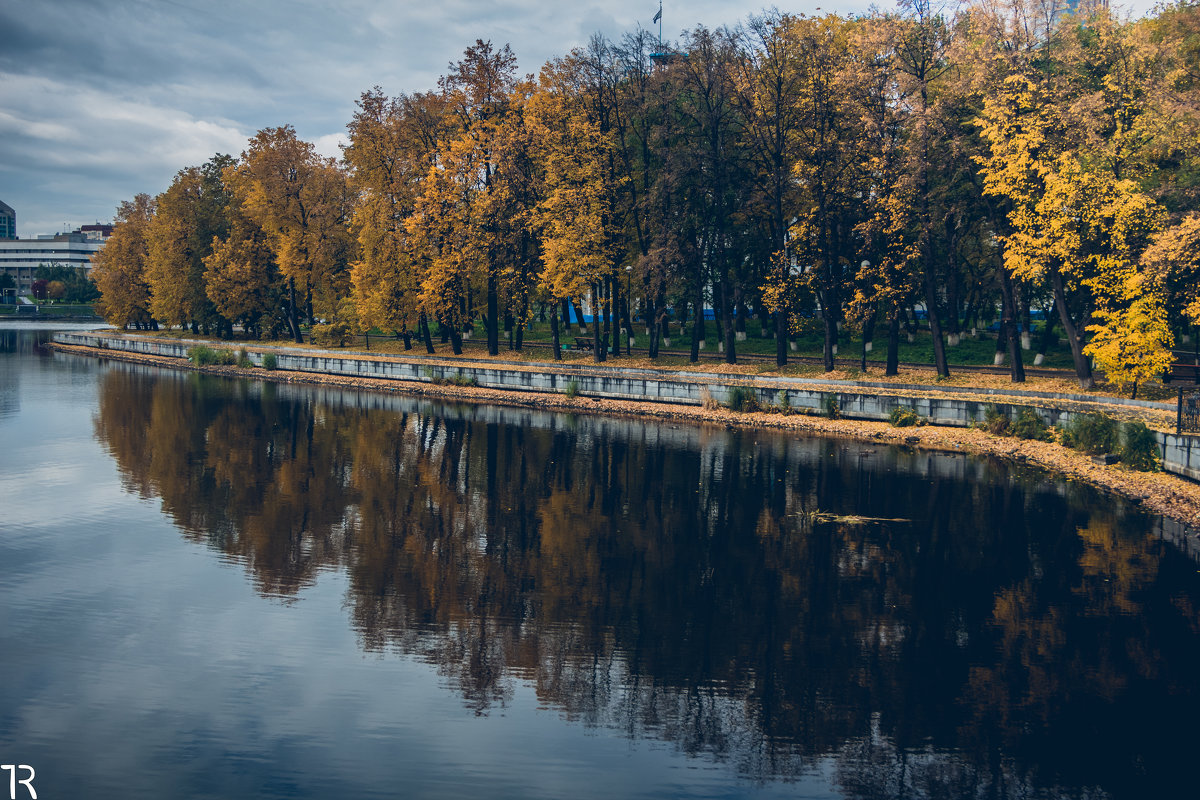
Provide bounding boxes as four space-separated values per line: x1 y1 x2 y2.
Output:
94 0 1200 386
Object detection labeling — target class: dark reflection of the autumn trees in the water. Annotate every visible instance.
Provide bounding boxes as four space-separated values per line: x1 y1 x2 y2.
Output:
95 366 1200 798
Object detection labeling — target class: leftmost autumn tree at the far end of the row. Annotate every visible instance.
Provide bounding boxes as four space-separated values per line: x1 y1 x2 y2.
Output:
91 194 157 330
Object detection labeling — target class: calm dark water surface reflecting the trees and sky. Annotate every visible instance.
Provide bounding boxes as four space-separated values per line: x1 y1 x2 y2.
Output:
0 330 1200 800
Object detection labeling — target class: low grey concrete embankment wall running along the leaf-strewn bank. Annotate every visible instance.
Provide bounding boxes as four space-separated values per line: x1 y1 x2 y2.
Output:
54 331 1200 481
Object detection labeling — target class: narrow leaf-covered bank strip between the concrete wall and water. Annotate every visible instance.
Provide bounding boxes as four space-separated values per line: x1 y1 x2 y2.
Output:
53 343 1200 548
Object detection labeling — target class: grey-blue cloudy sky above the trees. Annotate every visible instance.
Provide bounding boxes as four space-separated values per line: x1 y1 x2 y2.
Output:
0 0 1152 237
